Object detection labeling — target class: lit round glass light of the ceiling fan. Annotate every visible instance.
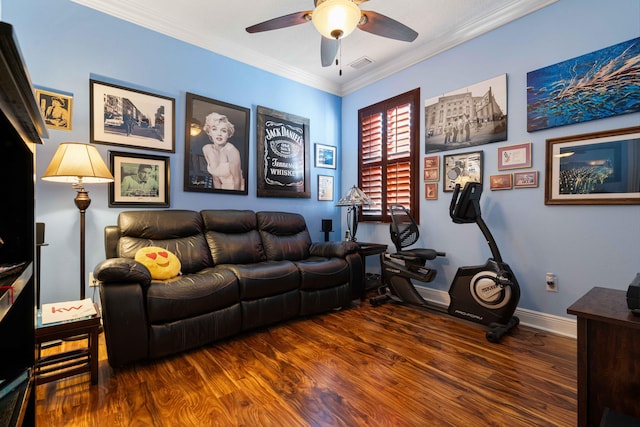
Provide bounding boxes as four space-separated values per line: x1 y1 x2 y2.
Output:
311 0 360 39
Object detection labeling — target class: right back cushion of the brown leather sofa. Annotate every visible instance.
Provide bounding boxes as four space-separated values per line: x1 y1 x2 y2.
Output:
256 212 311 261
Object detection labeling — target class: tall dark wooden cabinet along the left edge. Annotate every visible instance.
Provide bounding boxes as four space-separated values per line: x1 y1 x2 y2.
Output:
0 22 47 425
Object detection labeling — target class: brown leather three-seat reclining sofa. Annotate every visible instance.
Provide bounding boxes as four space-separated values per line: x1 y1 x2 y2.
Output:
94 210 363 367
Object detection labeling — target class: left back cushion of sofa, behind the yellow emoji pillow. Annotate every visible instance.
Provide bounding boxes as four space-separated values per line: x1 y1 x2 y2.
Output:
117 210 213 274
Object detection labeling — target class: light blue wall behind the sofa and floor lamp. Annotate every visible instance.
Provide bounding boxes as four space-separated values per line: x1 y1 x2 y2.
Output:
2 0 342 302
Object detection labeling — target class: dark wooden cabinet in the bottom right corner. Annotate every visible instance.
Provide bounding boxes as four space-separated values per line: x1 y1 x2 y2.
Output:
567 287 640 427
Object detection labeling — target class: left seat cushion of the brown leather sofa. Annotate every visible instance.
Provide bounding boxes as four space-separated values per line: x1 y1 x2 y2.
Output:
146 268 239 323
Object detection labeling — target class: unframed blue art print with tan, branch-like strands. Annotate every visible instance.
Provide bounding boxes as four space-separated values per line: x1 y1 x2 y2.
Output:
527 38 640 132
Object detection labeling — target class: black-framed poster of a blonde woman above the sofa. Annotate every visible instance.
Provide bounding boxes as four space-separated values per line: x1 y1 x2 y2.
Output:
184 92 251 195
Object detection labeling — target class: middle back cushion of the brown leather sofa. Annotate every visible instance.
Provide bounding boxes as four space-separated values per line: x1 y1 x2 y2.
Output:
200 210 266 265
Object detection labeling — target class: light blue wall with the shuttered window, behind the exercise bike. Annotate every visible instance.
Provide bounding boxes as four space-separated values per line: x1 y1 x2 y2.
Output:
342 0 640 316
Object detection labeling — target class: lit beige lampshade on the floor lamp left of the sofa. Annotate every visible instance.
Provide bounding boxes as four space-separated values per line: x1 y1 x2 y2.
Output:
42 142 113 184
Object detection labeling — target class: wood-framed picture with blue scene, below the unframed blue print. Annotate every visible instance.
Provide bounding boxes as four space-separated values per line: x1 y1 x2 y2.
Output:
544 126 640 205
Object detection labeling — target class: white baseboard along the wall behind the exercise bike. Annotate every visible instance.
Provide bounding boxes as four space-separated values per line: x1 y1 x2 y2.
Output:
416 286 577 338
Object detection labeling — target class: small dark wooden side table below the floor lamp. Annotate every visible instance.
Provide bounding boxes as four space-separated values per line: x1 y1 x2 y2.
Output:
34 307 100 385
